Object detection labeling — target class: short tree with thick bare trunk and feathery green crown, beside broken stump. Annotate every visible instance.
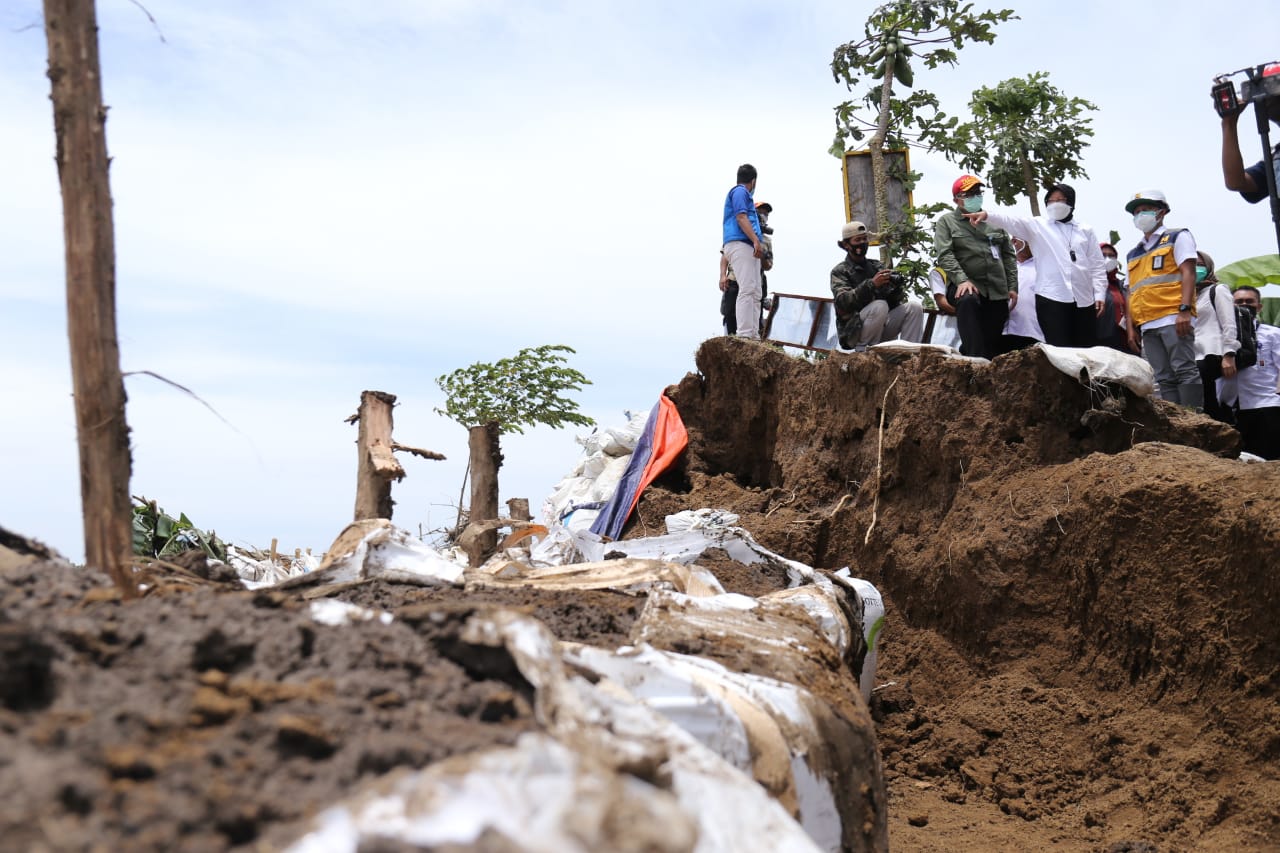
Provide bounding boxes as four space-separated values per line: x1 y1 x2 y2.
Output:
435 345 595 565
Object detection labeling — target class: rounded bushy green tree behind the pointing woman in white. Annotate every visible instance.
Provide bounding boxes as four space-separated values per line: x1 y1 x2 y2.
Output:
961 72 1098 216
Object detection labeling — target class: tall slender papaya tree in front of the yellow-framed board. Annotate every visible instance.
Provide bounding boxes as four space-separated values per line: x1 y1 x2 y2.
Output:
831 0 1016 280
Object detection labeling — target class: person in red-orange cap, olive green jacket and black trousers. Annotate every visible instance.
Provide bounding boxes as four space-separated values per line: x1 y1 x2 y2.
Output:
933 174 1018 359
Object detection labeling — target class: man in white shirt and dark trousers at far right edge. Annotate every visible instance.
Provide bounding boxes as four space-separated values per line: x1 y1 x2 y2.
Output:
1217 286 1280 459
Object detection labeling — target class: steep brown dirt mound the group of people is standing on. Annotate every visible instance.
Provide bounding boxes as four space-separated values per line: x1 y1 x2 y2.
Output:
627 338 1280 850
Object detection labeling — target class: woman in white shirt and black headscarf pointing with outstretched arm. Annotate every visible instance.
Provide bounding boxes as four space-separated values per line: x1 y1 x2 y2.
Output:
968 183 1107 347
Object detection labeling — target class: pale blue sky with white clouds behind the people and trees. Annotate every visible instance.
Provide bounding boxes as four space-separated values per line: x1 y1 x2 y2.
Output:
0 0 1280 557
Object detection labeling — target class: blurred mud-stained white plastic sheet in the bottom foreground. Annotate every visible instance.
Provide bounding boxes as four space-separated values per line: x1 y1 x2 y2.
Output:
289 612 838 853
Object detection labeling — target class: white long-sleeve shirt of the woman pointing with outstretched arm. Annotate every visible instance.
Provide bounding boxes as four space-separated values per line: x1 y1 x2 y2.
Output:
987 210 1107 307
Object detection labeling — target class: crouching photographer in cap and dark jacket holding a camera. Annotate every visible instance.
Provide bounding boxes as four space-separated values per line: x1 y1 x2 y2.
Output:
831 222 924 350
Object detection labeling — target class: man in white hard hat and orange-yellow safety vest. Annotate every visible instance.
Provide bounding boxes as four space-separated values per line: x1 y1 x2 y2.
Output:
1124 190 1204 409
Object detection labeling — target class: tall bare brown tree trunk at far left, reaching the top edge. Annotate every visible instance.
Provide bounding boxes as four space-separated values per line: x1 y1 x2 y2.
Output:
45 0 137 597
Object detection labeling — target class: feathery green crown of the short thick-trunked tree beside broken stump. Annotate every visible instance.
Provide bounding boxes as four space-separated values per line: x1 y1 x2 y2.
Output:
435 345 595 433
